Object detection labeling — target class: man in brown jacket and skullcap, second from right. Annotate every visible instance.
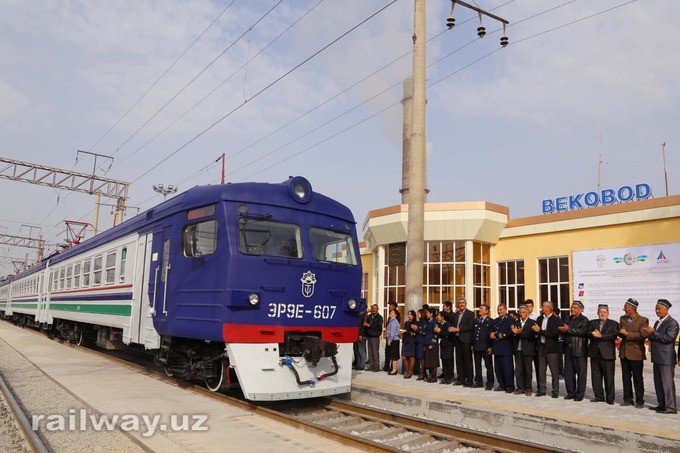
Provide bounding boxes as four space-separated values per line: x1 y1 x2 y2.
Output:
619 298 649 409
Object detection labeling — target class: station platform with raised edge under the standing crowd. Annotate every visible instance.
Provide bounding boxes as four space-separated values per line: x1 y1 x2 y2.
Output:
350 360 680 453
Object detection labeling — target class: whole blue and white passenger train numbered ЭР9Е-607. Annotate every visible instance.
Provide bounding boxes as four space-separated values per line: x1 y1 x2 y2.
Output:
0 177 365 400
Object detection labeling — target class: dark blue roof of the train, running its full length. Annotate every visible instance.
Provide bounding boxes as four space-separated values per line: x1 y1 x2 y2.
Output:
0 177 356 280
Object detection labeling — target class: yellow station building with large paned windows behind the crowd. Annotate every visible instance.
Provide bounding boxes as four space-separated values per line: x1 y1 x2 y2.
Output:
361 195 680 318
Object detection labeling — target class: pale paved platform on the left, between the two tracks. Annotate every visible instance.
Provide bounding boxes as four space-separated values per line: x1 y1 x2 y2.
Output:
0 322 362 452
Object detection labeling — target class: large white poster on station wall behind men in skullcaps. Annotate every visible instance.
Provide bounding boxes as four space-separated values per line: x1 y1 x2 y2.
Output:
572 242 680 324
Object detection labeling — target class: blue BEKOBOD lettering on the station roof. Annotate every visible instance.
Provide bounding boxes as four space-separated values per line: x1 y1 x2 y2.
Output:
541 183 652 214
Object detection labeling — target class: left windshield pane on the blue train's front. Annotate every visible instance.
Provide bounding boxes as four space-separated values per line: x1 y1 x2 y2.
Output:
238 218 302 258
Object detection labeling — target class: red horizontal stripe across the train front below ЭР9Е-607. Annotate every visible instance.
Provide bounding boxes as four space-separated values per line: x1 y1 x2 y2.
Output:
222 324 359 343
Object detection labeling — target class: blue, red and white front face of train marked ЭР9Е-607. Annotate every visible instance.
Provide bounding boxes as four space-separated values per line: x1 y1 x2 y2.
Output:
222 177 365 401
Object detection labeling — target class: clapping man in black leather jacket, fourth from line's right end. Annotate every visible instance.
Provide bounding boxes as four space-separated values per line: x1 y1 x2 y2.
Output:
558 300 590 401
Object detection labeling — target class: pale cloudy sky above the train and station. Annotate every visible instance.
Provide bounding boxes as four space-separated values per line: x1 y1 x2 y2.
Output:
0 0 680 275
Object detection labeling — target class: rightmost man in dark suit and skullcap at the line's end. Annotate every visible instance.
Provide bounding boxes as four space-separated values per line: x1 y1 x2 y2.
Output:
643 299 680 414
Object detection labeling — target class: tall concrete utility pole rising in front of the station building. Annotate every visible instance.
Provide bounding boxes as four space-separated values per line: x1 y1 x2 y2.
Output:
404 0 427 311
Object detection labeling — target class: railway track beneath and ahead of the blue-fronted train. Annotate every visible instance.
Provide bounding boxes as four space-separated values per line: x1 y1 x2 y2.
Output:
15 324 563 453
